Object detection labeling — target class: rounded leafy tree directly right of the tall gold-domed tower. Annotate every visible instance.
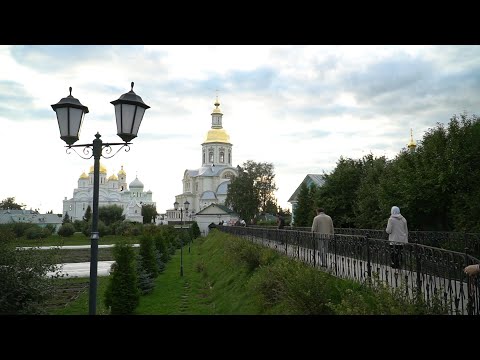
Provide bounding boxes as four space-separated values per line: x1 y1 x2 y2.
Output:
225 160 277 220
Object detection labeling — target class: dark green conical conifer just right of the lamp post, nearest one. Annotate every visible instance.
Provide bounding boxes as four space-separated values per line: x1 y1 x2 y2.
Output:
104 242 140 315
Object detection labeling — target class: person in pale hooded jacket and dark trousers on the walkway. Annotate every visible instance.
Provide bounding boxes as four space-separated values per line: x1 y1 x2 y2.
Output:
385 206 408 269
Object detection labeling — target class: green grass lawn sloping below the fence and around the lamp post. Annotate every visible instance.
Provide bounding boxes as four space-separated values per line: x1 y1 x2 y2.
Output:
51 235 260 315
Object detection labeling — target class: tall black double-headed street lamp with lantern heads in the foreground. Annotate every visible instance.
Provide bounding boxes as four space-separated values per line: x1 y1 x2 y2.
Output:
52 82 150 315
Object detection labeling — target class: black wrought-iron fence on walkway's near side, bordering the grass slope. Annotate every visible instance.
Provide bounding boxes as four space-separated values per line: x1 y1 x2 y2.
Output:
218 226 480 315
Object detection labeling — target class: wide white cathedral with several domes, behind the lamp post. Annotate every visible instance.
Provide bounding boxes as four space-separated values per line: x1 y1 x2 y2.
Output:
63 164 156 223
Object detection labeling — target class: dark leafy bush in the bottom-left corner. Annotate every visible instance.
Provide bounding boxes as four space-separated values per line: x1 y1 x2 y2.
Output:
0 227 59 315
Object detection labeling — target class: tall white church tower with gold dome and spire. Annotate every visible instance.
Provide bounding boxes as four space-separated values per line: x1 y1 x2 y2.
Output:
167 97 238 221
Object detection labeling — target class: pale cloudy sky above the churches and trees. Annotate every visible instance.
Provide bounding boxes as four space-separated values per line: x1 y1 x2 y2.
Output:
0 45 480 213
